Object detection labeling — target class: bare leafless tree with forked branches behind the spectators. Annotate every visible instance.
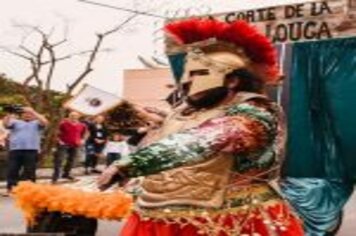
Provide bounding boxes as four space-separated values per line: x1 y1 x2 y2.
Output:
2 13 138 162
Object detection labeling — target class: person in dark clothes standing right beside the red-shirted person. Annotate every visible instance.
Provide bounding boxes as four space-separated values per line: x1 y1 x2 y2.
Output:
85 115 108 174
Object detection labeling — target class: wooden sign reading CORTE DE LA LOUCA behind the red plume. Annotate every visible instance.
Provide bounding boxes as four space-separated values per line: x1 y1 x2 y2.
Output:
210 0 356 43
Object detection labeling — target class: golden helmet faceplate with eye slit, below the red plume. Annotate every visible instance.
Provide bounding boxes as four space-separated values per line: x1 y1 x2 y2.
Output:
181 51 246 96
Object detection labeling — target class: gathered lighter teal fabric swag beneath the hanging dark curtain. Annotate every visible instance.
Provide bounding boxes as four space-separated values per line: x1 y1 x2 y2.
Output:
281 178 353 236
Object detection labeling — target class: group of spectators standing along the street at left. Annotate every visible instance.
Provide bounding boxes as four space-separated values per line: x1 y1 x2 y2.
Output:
0 107 162 195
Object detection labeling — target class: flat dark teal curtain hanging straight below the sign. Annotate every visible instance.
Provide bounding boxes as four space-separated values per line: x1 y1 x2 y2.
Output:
285 38 356 181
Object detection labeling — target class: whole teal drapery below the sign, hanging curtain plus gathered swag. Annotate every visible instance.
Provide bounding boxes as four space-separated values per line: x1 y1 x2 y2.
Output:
281 38 356 236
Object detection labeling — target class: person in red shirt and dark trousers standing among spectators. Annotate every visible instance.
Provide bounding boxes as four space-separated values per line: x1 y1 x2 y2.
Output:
52 112 88 183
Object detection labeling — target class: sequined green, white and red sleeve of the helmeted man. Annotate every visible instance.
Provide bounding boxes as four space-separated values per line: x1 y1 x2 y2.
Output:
114 99 278 177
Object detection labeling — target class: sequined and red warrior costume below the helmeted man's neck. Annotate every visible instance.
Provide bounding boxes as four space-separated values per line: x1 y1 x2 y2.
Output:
117 93 303 236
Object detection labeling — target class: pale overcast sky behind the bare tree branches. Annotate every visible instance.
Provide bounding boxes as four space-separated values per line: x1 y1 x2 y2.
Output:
0 0 308 95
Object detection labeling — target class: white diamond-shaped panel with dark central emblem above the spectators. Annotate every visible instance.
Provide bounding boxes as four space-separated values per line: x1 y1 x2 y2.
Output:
64 85 122 116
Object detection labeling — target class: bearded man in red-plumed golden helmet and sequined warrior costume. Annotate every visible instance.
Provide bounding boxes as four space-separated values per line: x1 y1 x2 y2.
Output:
98 19 303 236
